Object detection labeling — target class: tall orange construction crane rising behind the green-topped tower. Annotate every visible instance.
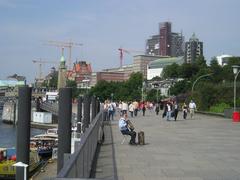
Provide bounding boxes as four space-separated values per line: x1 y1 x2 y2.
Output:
47 41 83 69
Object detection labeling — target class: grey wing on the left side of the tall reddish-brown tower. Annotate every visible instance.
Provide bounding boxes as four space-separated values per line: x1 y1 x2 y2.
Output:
145 34 160 56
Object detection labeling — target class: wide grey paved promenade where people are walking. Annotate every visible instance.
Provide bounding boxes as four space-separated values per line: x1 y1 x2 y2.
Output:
96 112 240 180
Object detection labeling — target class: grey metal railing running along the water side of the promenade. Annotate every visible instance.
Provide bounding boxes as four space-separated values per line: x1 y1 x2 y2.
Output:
57 111 103 179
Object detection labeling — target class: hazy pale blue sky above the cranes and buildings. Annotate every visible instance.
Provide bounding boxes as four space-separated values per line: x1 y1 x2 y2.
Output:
0 0 240 83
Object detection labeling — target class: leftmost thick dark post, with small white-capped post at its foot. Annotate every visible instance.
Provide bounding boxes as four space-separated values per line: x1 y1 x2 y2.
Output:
16 86 32 180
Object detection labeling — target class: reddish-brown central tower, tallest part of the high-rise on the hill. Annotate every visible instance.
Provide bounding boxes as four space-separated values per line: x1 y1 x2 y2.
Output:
159 22 172 56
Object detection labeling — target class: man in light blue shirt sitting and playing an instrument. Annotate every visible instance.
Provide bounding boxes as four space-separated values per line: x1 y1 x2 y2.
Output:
118 114 136 145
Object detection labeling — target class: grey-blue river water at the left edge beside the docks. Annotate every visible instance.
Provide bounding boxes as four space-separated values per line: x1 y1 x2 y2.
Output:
0 112 45 148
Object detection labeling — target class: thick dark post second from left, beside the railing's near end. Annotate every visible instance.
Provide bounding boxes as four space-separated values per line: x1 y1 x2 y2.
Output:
57 88 72 173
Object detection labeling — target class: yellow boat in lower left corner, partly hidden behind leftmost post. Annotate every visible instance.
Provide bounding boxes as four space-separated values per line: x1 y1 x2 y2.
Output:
0 148 42 179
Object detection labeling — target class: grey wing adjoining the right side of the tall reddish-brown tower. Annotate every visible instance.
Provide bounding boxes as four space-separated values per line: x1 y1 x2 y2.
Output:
170 32 184 57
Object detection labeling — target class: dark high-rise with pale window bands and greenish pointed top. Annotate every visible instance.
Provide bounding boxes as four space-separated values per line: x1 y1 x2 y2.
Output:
185 33 203 63
